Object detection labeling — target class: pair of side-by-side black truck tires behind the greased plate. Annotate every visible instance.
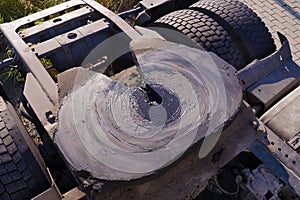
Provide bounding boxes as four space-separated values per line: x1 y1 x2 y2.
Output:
154 0 276 70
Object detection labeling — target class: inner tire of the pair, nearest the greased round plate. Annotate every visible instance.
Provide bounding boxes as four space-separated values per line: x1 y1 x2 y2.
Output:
154 9 246 69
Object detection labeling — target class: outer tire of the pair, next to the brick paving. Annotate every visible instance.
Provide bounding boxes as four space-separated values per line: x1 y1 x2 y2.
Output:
190 0 276 63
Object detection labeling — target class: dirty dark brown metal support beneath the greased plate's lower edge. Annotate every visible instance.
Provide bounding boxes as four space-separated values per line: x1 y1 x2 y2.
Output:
92 104 258 200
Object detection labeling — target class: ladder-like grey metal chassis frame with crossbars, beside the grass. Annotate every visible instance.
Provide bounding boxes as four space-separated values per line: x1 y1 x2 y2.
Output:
0 0 140 135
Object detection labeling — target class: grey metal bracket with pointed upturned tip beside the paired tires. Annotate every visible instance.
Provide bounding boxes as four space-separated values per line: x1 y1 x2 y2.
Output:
238 40 300 111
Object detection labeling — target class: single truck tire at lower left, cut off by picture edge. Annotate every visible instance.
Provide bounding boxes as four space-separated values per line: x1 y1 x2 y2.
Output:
0 96 50 200
